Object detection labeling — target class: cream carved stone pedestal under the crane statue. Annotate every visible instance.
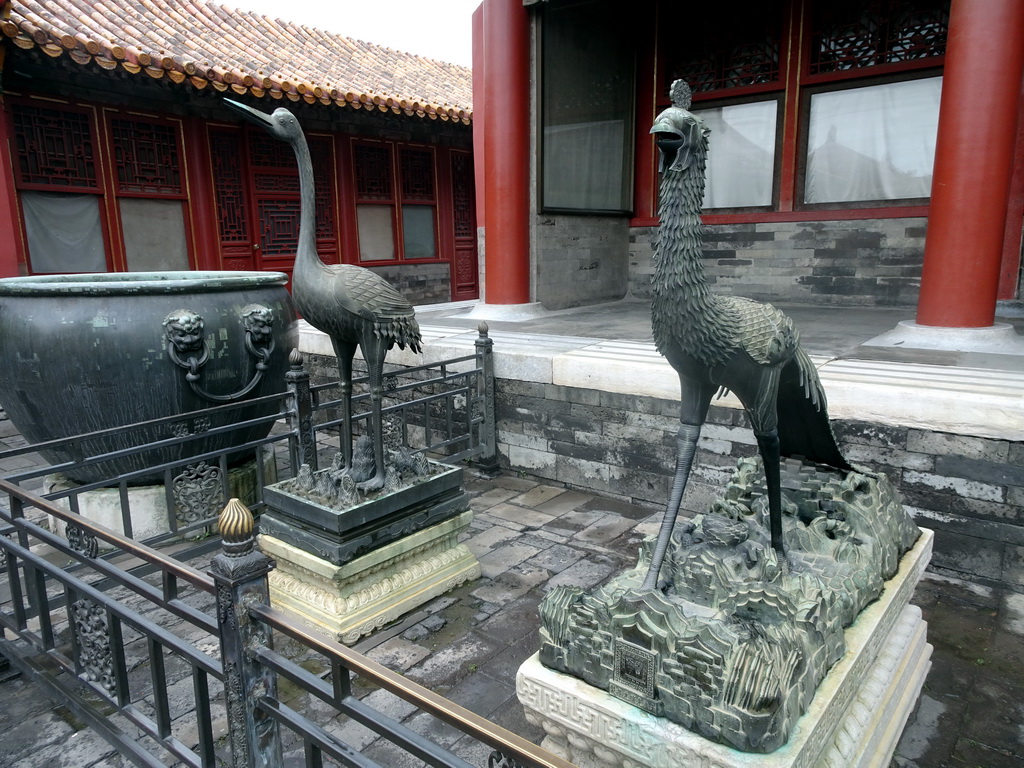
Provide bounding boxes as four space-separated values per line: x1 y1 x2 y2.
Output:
259 510 480 644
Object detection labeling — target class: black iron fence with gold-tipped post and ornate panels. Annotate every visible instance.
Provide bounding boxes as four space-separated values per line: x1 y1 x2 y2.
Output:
0 329 568 768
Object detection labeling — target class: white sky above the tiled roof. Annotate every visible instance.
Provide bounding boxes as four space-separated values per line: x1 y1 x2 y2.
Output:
224 0 481 67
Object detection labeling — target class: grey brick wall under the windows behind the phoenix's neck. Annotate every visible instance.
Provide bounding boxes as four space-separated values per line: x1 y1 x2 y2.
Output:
629 218 926 306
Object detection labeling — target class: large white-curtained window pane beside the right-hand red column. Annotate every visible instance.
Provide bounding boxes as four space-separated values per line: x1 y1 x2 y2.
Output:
804 78 942 203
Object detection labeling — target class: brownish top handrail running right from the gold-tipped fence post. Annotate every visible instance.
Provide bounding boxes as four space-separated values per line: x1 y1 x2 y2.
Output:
249 604 574 768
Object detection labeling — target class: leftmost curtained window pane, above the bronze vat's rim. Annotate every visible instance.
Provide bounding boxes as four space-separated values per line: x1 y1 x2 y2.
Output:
20 191 106 273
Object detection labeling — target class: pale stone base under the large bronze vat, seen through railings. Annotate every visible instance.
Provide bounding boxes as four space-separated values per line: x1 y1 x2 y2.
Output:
43 452 278 551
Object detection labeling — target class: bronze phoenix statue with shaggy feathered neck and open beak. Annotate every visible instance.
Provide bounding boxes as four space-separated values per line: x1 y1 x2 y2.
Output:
642 80 852 591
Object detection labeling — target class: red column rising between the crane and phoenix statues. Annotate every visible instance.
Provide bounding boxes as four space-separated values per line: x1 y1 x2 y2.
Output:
482 0 529 304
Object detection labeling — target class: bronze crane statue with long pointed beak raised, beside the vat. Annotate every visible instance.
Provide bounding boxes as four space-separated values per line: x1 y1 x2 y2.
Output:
224 99 422 490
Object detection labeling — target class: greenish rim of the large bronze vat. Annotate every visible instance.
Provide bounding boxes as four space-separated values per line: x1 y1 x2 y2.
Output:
0 271 288 296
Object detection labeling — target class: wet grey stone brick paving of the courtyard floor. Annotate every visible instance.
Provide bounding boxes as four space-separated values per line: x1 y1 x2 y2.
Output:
0 460 1024 768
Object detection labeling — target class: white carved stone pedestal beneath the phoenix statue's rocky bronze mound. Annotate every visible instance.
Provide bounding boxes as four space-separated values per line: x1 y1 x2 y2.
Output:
516 529 933 768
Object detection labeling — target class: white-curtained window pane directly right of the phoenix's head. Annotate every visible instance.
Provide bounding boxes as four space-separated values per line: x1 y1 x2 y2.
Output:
693 99 778 208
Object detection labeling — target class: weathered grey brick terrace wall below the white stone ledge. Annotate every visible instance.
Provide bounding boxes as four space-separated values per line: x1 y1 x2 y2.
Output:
497 379 1024 592
